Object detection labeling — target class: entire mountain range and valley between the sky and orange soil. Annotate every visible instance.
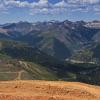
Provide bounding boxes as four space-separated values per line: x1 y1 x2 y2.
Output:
0 20 100 85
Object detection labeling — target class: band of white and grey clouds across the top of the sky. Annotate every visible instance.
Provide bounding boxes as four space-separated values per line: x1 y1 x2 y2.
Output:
0 0 100 14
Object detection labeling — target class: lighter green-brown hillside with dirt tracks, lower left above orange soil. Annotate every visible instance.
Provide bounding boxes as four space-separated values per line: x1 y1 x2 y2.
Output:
0 54 56 81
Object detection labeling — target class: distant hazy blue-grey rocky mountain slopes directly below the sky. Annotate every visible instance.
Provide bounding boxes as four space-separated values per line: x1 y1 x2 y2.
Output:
0 20 100 60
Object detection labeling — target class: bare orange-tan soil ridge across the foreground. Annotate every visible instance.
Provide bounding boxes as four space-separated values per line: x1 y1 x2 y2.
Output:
0 81 100 100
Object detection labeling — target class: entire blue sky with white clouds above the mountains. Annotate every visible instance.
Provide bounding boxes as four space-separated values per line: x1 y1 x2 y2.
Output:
0 0 100 24
